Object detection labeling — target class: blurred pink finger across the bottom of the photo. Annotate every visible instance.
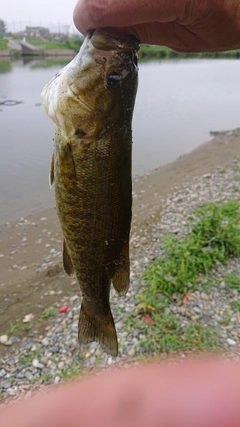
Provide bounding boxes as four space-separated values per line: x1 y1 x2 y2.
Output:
0 360 240 427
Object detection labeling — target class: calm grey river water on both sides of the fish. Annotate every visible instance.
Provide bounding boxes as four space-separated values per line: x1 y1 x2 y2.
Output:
0 59 240 224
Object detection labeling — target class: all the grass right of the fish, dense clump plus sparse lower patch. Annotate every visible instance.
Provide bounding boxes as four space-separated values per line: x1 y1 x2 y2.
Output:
125 200 240 353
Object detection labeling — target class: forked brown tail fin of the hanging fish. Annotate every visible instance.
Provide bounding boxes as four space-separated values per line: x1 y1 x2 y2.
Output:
78 299 118 357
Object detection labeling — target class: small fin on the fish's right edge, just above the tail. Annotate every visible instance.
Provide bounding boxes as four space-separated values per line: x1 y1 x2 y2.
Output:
111 240 130 295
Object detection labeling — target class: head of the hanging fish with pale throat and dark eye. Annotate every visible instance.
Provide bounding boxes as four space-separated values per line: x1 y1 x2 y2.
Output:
41 29 139 139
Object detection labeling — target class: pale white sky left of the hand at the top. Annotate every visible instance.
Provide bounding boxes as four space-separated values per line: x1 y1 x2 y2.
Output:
0 0 77 31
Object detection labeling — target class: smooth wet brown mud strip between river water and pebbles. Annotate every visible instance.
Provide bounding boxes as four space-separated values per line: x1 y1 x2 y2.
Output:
0 129 240 356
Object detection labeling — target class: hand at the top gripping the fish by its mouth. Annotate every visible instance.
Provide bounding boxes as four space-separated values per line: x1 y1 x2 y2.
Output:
74 0 240 52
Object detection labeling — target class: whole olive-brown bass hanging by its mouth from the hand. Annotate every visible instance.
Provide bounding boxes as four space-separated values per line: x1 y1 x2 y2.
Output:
41 29 139 357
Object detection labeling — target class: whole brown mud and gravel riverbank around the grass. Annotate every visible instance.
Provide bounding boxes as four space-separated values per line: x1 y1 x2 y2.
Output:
0 129 240 402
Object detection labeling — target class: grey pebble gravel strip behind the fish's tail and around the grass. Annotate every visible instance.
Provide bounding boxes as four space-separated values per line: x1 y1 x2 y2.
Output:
0 155 240 402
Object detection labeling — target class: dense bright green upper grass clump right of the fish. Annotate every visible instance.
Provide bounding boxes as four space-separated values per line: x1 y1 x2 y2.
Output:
142 200 240 302
